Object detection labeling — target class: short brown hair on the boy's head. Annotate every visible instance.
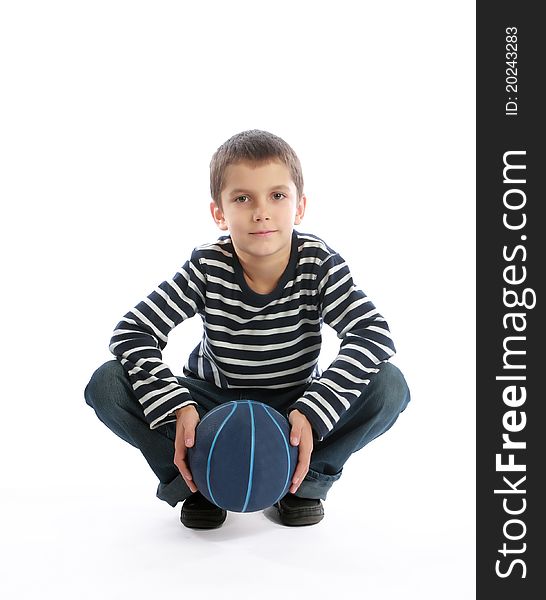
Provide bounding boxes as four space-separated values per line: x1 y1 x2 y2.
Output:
210 129 303 207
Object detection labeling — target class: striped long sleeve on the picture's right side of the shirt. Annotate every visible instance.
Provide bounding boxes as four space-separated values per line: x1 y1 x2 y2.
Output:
289 253 396 441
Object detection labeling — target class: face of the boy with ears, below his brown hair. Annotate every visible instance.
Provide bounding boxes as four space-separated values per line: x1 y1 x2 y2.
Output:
210 161 306 260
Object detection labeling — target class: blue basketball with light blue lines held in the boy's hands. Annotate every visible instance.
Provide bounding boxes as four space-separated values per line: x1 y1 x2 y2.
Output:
188 400 298 512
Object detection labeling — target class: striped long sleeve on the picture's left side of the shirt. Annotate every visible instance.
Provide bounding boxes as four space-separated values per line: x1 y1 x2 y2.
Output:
109 250 205 429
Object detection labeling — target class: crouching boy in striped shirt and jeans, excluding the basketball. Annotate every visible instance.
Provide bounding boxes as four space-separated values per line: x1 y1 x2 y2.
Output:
85 130 410 528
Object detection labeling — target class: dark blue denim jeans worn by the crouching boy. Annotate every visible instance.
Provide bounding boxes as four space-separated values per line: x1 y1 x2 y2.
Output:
84 359 410 506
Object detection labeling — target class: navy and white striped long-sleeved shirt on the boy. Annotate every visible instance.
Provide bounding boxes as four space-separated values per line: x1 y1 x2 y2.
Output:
110 230 395 441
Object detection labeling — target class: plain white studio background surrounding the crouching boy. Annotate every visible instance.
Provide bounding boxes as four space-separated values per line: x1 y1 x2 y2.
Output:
0 0 475 600
